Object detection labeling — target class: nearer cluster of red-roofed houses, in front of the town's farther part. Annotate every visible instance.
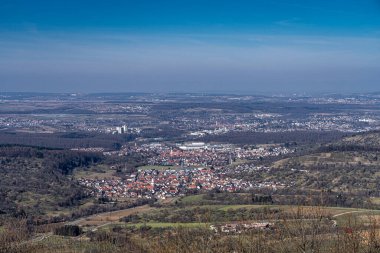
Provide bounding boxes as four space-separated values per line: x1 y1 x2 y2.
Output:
79 168 254 199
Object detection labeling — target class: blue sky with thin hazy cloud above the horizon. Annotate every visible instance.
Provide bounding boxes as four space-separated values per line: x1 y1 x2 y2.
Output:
0 0 380 93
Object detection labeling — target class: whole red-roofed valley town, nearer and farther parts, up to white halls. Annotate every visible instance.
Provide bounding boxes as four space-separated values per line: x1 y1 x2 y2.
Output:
79 142 293 199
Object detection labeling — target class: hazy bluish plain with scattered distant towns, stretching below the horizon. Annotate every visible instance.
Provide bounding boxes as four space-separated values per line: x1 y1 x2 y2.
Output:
0 94 380 138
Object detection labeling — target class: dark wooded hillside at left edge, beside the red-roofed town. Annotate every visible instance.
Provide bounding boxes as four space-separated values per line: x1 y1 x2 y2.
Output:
0 145 102 216
